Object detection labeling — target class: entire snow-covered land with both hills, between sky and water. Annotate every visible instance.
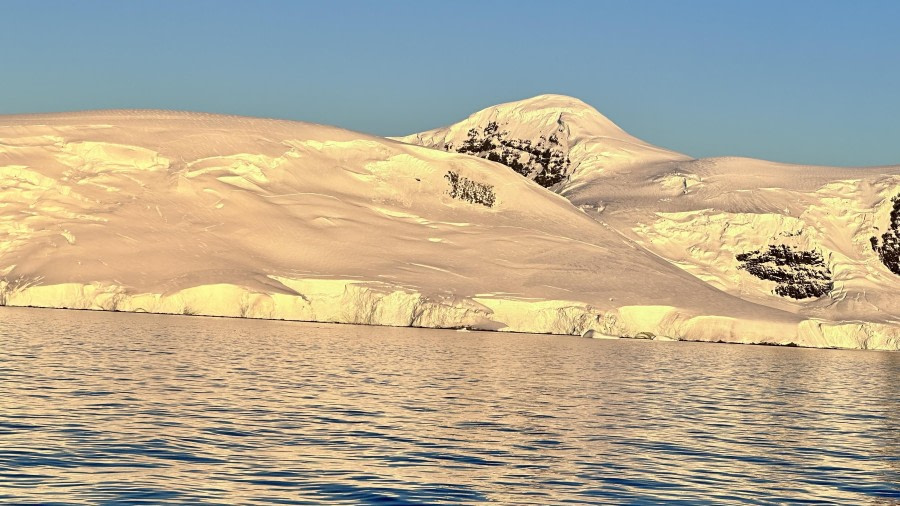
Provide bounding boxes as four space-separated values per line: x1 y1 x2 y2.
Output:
0 100 900 350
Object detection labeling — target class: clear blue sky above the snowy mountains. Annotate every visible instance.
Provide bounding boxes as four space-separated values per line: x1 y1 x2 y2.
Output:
0 0 900 165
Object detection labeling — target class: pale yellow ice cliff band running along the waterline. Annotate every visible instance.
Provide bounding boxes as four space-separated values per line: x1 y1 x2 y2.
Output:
0 280 900 351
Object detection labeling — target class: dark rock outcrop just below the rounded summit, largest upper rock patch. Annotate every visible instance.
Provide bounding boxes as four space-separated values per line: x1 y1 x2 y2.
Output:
444 121 571 188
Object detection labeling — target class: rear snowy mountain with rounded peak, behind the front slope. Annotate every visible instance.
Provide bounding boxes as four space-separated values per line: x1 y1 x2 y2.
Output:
402 95 900 348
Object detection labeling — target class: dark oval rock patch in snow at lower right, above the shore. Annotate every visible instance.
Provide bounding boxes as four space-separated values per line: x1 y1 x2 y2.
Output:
736 245 834 299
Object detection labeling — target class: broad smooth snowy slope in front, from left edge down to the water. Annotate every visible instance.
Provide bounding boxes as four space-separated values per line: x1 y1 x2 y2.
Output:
0 111 900 349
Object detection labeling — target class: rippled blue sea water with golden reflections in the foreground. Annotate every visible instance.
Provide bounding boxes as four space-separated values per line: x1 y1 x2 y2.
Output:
0 307 900 504
